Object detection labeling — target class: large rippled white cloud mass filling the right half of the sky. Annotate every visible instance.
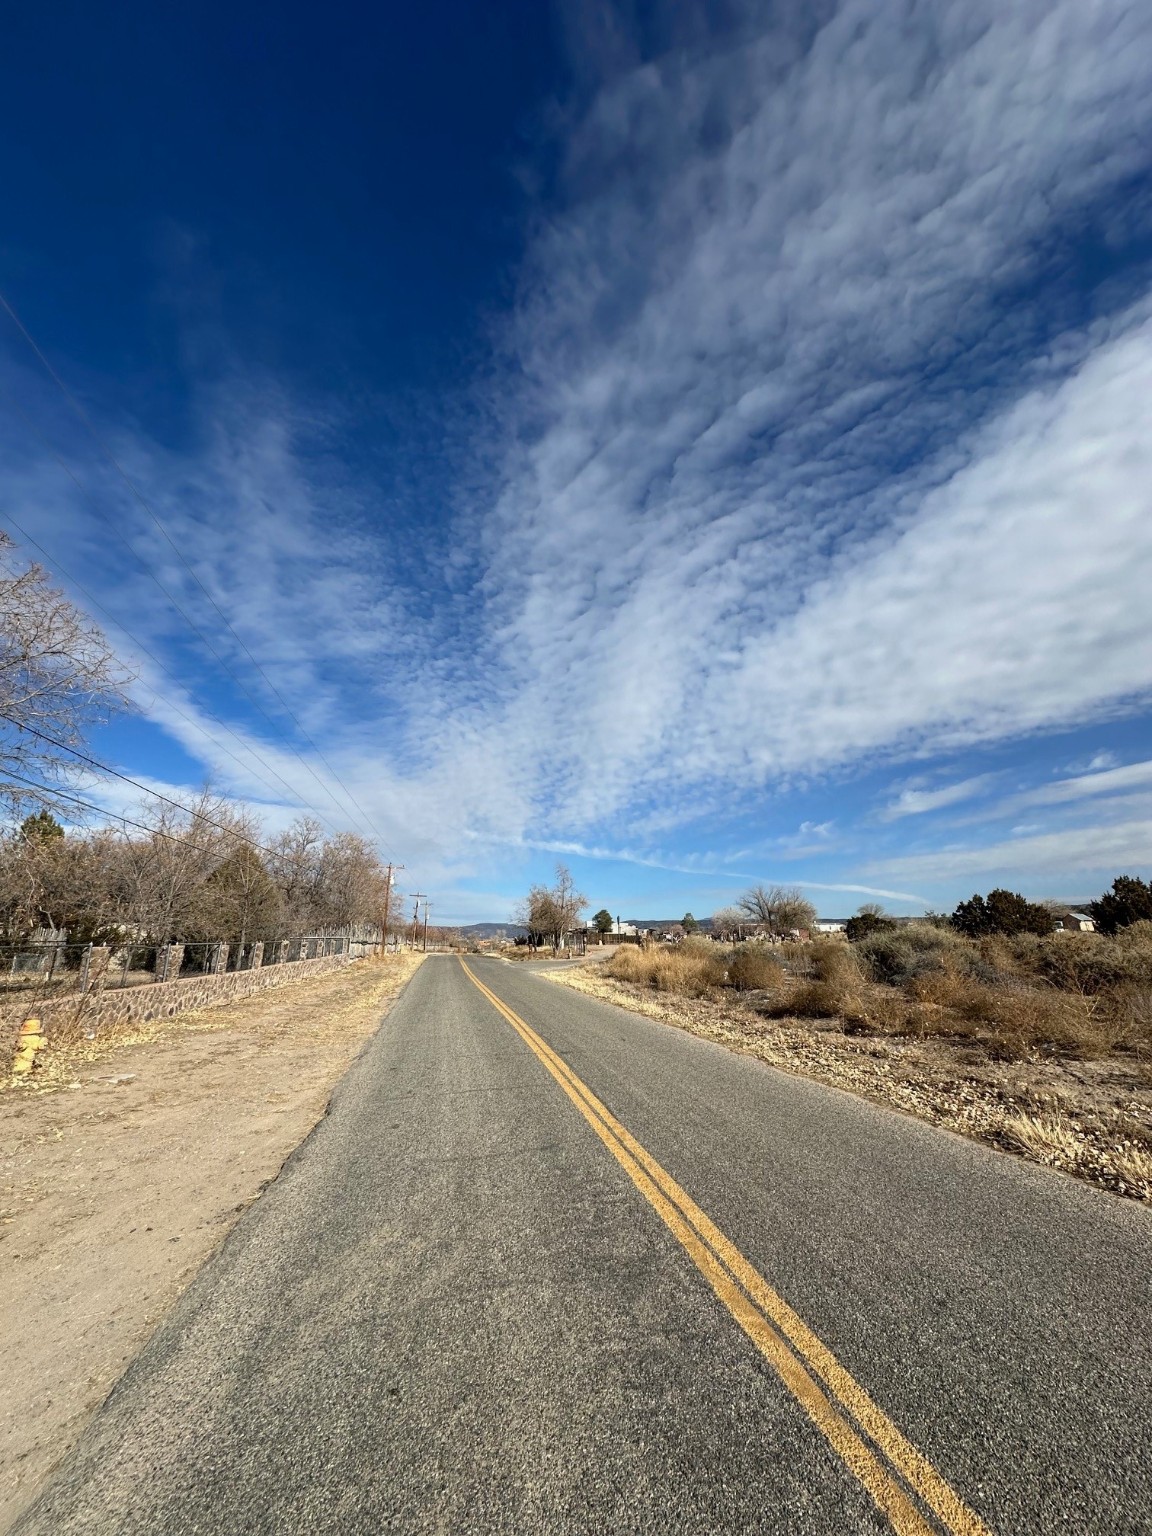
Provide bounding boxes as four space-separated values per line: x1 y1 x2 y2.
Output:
479 3 1152 816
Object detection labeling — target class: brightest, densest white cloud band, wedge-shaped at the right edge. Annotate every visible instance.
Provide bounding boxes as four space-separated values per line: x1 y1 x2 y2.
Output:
712 310 1152 768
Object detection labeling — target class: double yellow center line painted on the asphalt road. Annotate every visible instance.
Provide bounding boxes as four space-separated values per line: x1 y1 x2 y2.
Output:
461 962 991 1536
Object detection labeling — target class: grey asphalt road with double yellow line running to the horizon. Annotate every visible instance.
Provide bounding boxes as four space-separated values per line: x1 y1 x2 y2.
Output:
17 957 1152 1536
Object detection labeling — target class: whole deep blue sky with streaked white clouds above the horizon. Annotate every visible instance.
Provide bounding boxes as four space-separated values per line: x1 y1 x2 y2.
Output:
0 0 1152 922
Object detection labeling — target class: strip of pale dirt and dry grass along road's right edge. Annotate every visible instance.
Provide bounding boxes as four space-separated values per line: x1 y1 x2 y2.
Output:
538 966 1152 1200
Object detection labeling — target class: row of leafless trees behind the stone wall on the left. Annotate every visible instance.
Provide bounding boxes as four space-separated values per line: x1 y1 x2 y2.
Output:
0 531 401 945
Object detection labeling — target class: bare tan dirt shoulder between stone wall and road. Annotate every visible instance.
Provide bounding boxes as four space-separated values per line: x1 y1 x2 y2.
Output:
0 954 422 1530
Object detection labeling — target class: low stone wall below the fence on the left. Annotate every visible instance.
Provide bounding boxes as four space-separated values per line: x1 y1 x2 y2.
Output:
0 955 349 1064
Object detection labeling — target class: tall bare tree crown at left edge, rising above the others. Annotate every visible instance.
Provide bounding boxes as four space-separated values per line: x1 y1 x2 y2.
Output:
0 533 131 805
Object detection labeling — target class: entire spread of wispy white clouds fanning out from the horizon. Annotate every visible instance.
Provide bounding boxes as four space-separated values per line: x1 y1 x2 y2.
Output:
12 0 1152 900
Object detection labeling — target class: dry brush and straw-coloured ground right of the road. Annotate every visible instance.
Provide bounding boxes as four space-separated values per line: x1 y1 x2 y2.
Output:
550 876 1152 1200
